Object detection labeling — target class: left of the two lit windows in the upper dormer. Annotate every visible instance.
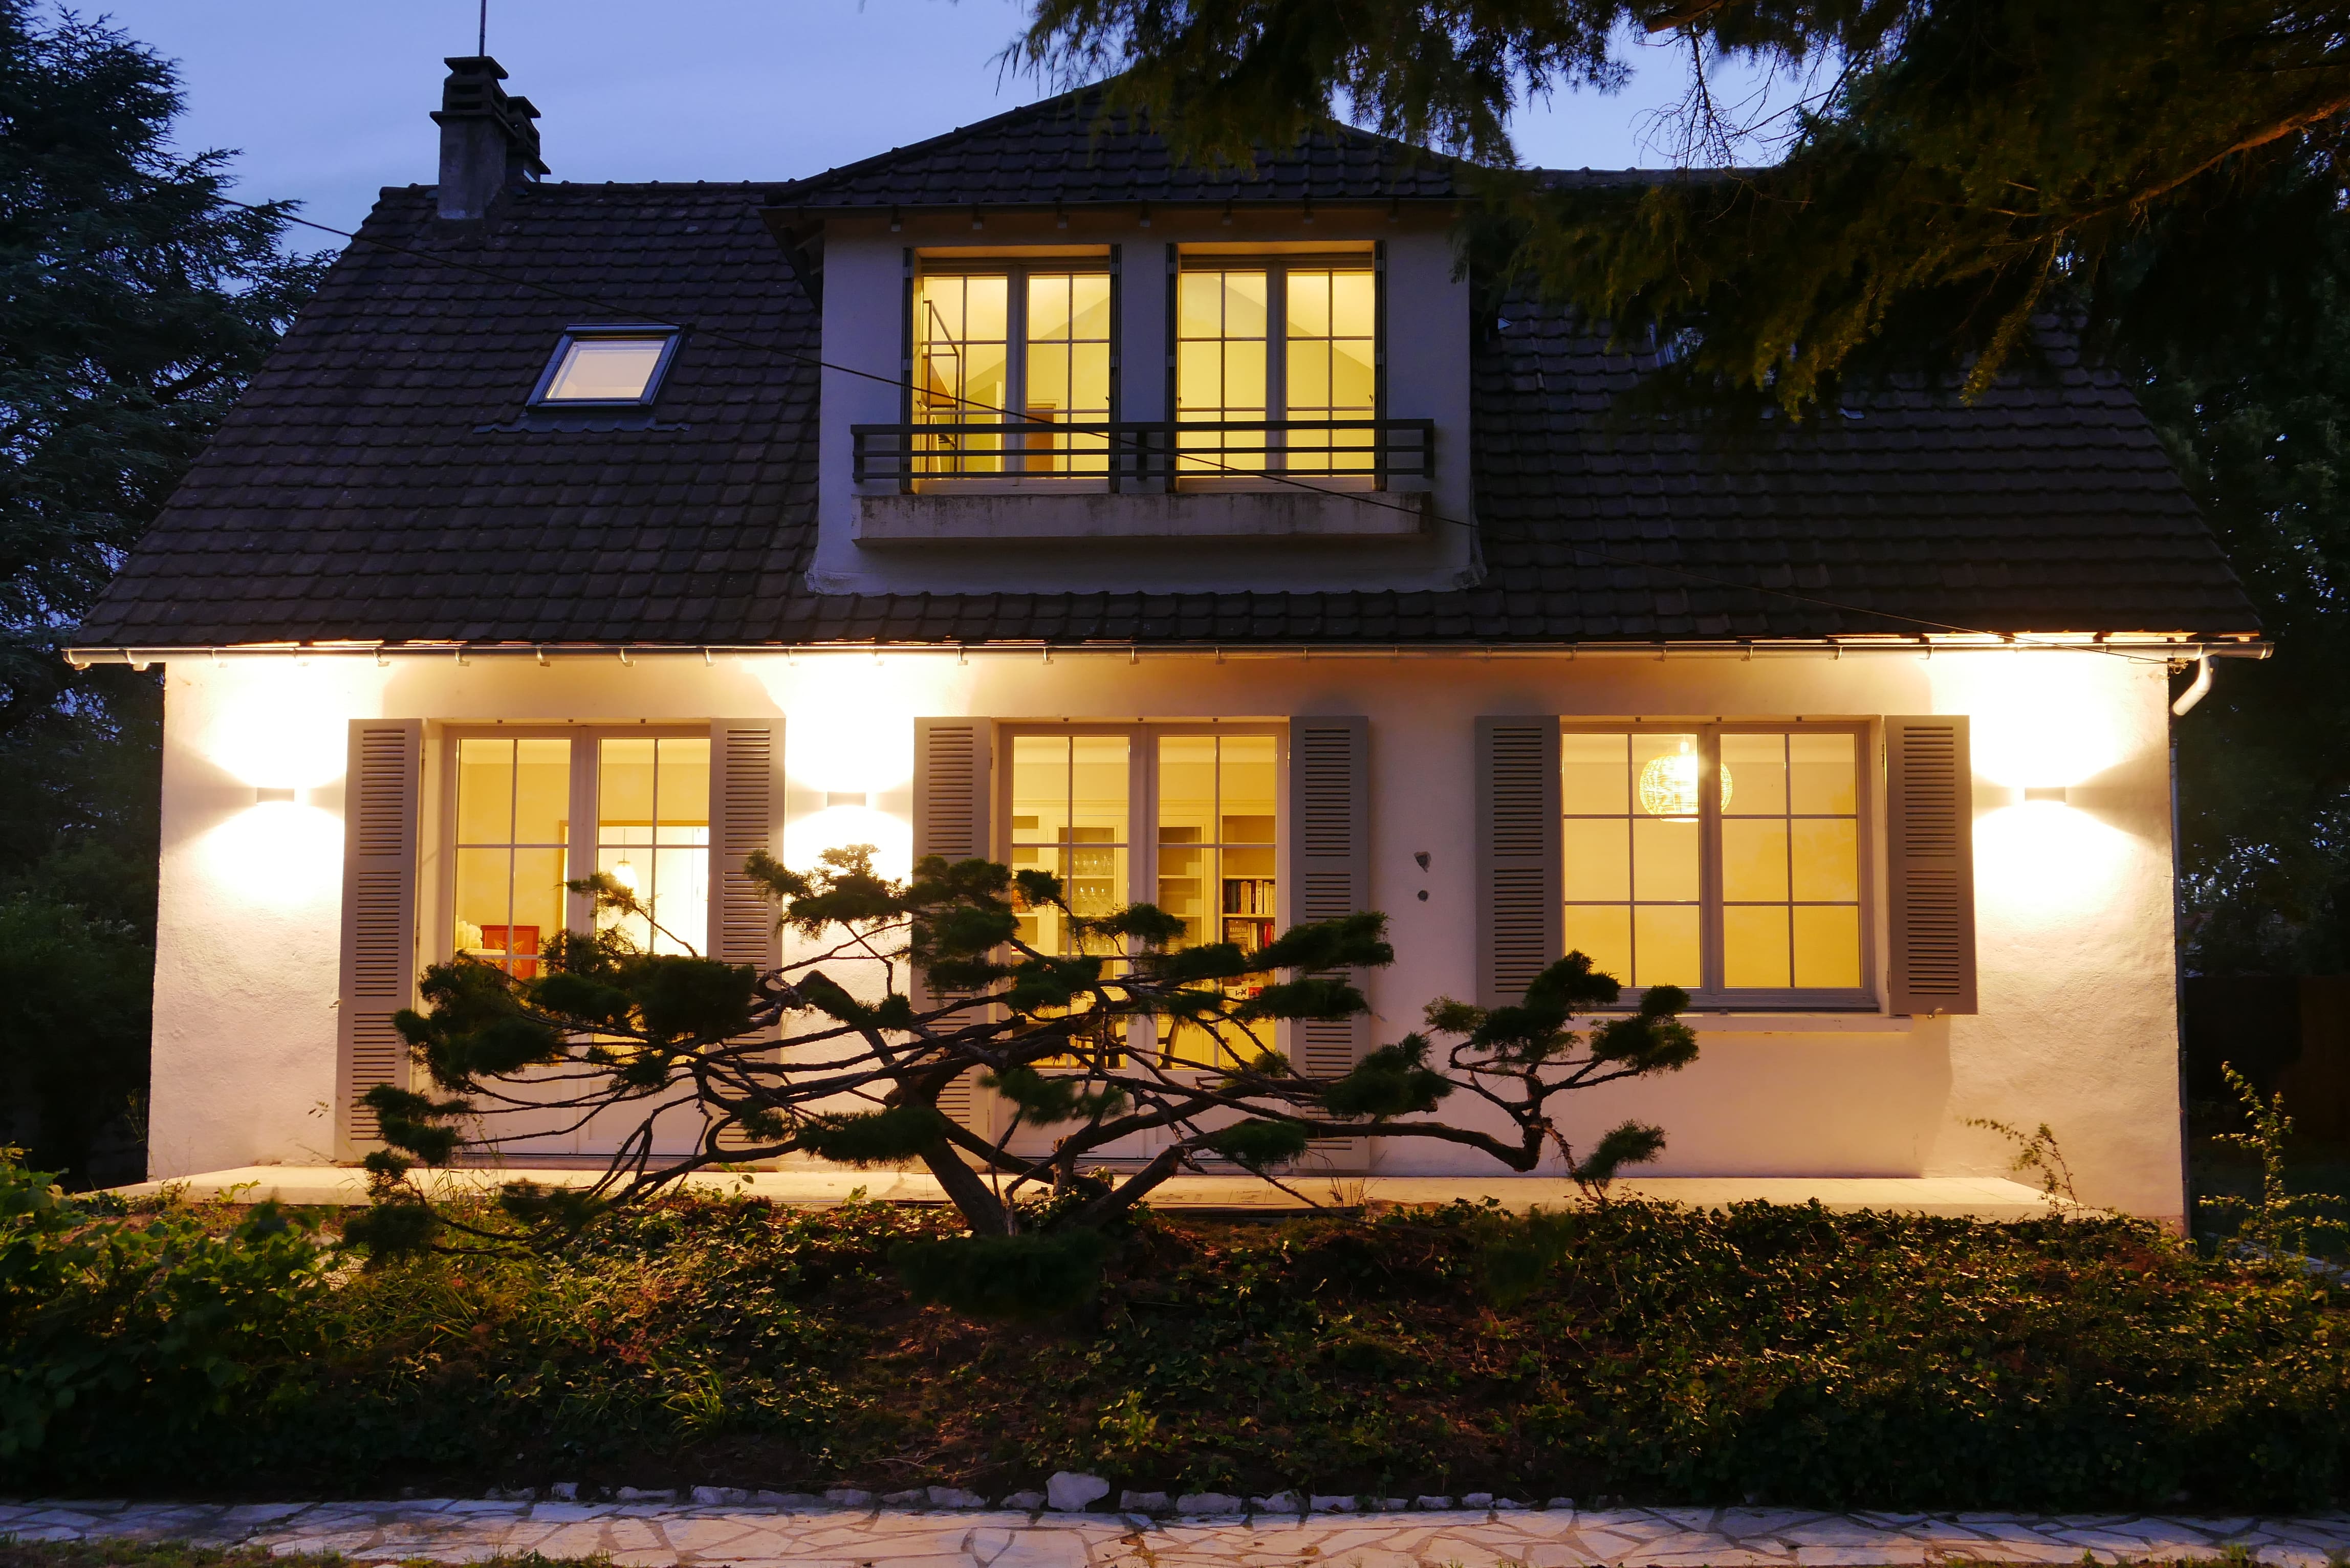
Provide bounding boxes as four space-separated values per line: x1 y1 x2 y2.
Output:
912 258 1112 477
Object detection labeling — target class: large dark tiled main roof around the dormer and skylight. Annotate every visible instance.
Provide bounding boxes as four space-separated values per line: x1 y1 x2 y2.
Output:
80 107 2256 646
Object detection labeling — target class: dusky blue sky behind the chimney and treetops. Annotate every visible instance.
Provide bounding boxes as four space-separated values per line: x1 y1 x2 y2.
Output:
92 0 1729 249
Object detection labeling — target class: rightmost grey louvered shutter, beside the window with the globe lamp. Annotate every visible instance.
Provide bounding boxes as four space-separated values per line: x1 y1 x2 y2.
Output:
1885 714 1974 1013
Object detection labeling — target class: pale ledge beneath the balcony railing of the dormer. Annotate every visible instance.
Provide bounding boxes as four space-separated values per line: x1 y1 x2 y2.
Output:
851 487 1426 548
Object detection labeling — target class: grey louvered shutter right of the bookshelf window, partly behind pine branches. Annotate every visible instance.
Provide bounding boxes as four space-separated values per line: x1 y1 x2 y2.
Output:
1288 714 1370 1077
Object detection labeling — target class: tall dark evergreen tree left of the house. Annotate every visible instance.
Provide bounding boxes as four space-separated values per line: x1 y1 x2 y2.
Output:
0 0 324 1185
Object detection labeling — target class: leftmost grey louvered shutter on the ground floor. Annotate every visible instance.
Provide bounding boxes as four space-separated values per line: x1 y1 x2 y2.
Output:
334 720 425 1152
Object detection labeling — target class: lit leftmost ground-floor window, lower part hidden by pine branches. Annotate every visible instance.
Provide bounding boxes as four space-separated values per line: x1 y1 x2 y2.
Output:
449 731 710 981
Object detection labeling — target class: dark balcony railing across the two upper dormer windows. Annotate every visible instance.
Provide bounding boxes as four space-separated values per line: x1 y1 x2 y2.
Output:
851 419 1436 489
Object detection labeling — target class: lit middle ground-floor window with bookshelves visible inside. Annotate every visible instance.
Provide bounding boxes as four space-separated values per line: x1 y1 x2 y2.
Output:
1006 726 1288 1062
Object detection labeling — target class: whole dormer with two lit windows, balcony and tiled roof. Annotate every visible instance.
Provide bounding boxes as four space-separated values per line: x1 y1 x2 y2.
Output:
766 94 1476 593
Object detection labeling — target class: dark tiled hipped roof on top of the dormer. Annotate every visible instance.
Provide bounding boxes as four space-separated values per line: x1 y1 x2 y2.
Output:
775 92 1460 209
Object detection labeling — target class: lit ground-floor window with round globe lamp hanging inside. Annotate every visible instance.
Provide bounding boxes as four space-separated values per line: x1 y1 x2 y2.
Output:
1560 724 1868 1004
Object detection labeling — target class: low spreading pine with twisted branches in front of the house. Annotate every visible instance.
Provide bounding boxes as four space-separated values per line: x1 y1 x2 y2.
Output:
348 844 1696 1316
